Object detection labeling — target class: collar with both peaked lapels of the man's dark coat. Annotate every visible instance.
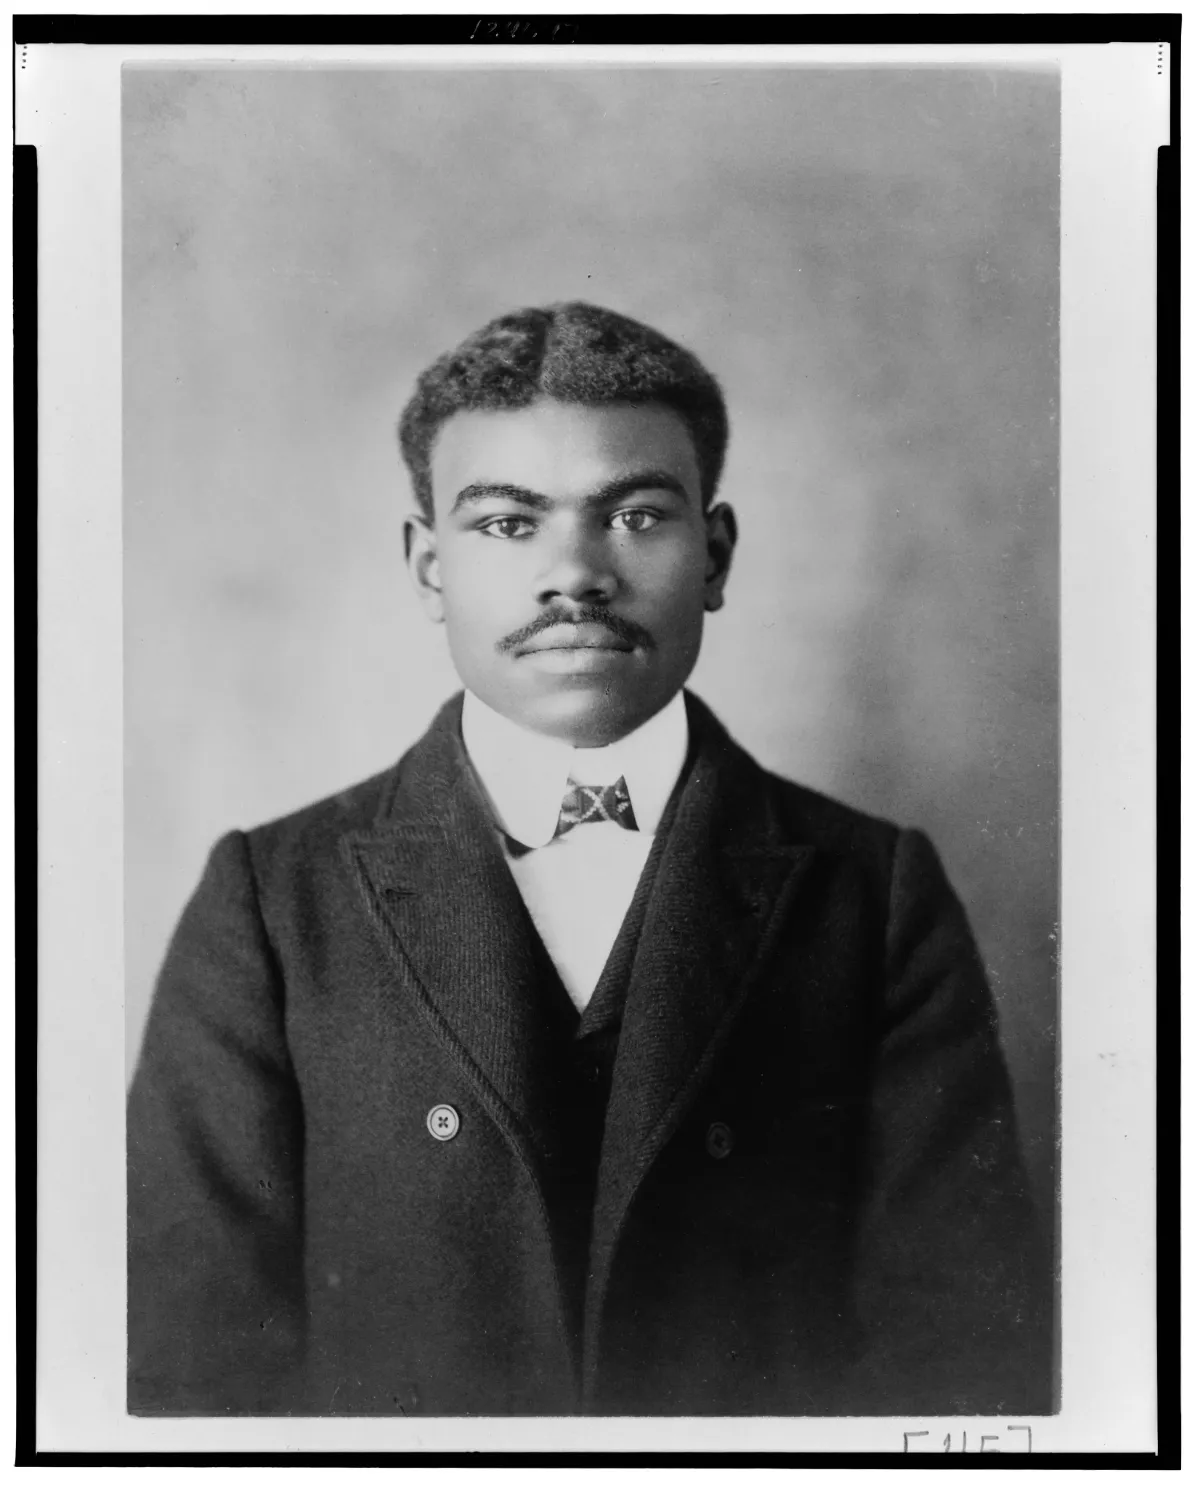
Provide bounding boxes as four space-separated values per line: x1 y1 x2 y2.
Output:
344 693 813 1388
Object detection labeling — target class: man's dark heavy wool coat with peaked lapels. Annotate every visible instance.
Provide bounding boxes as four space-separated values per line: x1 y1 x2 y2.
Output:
128 698 1051 1415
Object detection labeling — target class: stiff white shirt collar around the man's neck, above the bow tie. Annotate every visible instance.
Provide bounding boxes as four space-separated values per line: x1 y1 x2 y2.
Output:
463 692 688 847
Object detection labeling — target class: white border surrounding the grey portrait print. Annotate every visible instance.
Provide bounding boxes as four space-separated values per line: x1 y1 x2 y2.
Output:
16 29 1170 1454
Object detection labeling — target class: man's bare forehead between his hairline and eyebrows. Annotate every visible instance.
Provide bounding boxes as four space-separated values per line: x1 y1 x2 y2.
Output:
430 399 700 500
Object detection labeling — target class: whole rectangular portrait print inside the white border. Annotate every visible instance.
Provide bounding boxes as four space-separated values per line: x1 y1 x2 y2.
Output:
122 65 1059 1418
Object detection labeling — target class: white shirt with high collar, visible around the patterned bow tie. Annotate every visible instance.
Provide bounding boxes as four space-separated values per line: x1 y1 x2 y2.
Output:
463 692 688 1012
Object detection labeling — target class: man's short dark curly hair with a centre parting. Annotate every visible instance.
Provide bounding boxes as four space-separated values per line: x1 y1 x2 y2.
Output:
399 301 730 518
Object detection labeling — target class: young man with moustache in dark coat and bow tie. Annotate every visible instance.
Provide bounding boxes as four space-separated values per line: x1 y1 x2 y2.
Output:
130 304 1050 1415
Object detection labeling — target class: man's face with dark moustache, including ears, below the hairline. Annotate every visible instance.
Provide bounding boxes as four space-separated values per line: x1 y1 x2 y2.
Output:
405 400 735 747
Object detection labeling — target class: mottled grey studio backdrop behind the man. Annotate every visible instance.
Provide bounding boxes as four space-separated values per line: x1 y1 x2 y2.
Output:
124 67 1059 1226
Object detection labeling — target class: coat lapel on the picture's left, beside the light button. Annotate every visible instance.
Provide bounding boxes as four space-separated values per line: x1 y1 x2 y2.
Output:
344 698 562 1168
